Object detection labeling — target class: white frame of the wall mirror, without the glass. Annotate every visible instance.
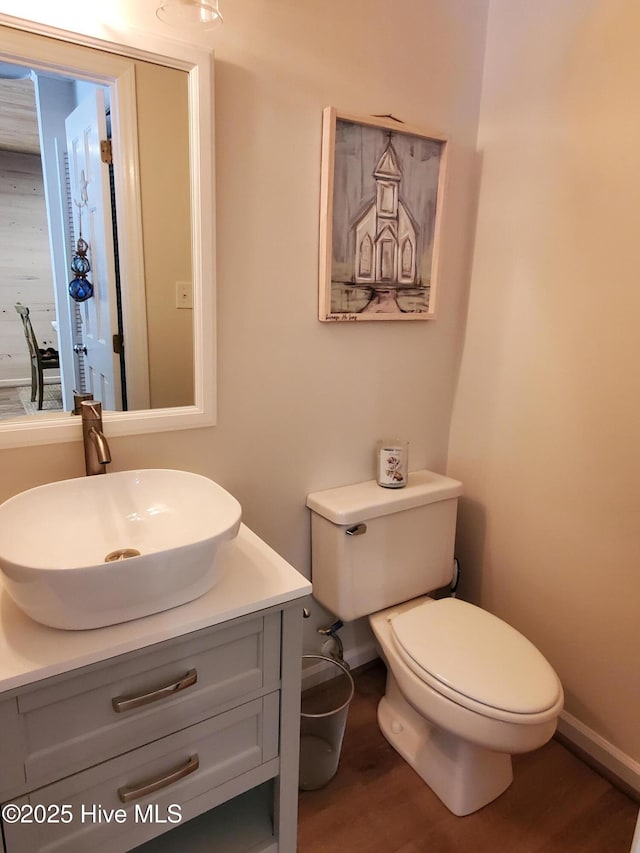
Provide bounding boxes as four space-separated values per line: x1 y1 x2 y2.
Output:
0 13 216 448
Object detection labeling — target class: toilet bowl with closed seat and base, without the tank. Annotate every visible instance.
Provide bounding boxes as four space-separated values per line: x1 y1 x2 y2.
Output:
369 597 563 815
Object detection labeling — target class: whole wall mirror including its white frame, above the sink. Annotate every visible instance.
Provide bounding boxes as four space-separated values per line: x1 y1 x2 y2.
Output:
0 15 214 446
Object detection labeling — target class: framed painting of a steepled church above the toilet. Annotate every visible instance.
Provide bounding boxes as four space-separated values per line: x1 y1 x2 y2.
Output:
319 107 447 322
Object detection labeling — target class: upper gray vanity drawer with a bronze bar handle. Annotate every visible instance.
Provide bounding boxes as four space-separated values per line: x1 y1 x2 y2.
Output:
18 613 280 788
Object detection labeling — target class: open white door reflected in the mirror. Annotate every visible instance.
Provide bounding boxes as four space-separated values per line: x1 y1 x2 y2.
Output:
66 89 122 410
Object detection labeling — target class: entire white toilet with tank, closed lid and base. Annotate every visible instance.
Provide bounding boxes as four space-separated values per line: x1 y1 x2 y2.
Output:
307 471 563 815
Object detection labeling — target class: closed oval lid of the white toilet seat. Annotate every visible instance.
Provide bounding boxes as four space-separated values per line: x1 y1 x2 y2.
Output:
391 598 561 714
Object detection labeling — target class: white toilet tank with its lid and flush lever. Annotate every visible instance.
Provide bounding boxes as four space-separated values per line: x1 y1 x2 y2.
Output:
307 471 462 621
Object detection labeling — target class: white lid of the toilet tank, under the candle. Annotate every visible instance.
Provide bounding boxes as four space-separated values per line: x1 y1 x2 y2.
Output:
307 471 462 524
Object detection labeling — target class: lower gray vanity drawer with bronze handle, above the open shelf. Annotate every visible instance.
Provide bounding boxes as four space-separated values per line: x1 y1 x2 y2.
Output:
4 691 279 853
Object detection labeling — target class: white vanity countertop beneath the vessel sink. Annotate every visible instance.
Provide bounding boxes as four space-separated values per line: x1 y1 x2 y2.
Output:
0 524 311 693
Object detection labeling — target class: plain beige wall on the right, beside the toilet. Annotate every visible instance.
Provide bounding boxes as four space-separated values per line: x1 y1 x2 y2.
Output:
448 0 640 772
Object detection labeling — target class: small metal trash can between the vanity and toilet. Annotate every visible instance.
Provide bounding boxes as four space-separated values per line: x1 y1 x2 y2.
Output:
299 655 354 791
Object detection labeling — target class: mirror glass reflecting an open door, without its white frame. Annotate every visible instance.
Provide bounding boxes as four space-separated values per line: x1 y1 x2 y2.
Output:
0 30 193 417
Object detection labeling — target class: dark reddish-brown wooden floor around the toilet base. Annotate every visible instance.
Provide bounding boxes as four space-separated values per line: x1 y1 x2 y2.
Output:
298 664 638 853
